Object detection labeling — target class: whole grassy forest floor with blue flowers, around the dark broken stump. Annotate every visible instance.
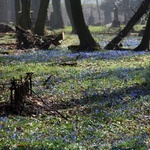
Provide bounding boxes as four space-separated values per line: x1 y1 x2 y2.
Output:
0 26 150 150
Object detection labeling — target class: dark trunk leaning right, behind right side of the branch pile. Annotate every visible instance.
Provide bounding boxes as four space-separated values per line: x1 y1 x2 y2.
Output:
34 0 49 35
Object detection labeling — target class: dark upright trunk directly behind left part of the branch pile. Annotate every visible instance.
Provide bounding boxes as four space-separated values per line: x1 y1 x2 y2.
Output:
19 0 31 30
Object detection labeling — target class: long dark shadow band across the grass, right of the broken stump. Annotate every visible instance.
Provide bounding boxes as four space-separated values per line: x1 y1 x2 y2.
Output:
51 80 150 112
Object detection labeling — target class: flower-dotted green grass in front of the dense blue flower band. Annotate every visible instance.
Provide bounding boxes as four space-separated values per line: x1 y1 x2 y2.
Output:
0 49 150 150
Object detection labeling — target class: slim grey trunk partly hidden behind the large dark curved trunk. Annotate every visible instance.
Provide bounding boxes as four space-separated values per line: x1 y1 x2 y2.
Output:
65 0 77 34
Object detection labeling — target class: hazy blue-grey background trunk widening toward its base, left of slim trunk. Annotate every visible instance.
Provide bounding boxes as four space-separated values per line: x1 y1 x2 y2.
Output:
50 0 64 29
